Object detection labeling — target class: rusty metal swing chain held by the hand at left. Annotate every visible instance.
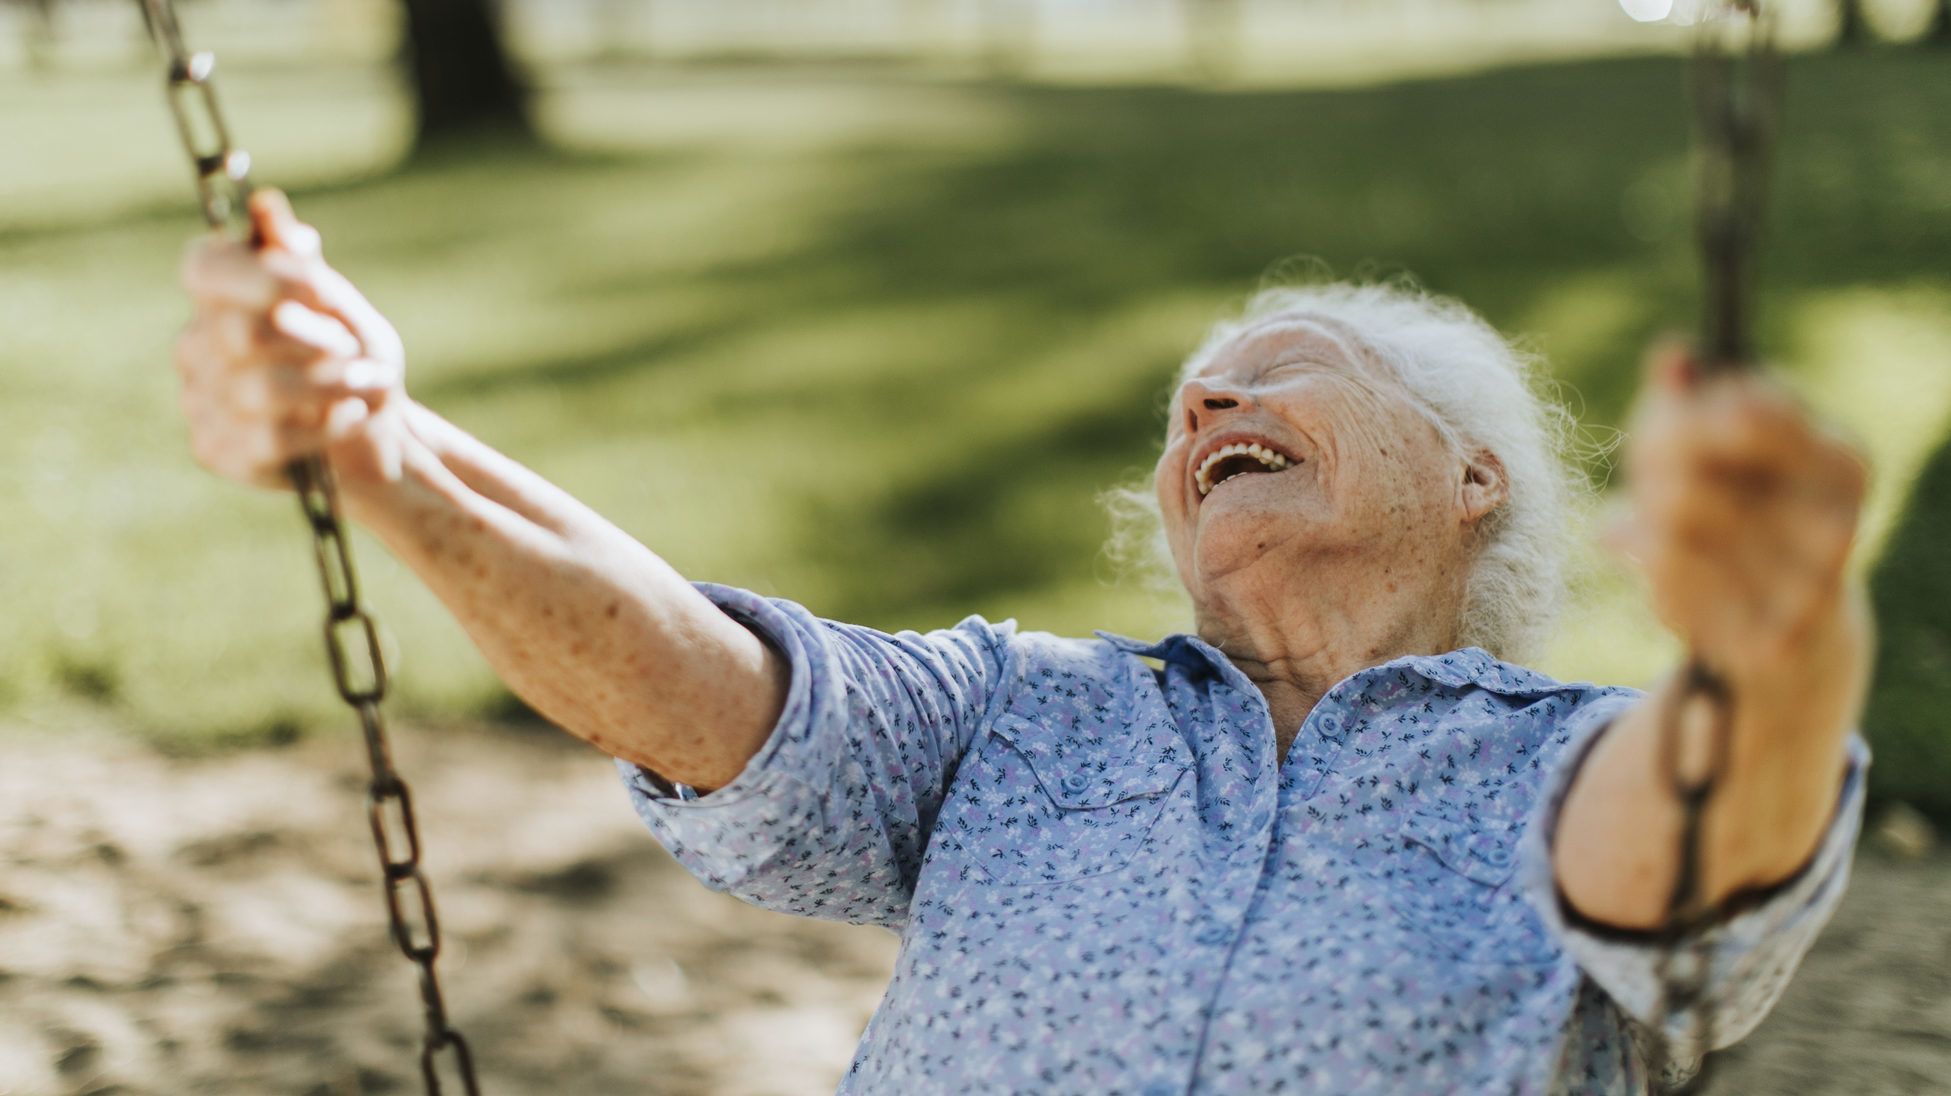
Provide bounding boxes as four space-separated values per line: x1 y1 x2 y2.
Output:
140 0 480 1096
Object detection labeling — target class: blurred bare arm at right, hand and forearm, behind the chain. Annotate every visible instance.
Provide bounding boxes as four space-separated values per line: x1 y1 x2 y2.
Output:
1553 351 1871 930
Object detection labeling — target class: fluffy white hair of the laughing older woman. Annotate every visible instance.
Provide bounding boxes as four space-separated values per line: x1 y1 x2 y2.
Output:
1106 281 1588 661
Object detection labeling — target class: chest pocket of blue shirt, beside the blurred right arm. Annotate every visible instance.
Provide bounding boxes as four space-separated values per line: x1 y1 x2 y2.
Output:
1383 805 1557 965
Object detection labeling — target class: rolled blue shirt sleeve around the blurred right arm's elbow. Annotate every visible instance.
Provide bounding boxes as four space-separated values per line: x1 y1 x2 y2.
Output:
1520 690 1869 1082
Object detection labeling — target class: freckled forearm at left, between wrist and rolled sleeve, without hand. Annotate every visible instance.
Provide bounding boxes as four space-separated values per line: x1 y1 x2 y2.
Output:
345 408 784 788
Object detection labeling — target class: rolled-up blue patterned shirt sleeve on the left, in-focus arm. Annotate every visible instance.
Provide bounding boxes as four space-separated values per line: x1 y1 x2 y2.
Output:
617 583 1015 930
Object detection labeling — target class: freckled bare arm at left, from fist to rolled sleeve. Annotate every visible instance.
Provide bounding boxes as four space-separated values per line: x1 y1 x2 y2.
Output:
178 191 786 790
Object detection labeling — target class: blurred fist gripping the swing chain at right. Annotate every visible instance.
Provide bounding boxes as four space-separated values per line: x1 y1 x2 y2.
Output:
1608 347 1867 694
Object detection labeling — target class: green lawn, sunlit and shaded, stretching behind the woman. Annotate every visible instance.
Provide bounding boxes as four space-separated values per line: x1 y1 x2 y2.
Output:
0 53 1951 770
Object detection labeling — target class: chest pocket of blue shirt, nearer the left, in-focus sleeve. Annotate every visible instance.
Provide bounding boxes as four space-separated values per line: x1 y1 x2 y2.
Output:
942 714 1188 883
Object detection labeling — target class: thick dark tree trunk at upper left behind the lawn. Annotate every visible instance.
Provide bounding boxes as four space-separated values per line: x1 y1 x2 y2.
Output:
402 0 535 148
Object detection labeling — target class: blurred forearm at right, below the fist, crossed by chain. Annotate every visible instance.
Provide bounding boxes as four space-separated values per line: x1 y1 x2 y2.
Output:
1553 592 1869 930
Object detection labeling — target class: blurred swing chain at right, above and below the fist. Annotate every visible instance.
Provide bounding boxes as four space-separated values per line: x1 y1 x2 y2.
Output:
1649 0 1781 1092
